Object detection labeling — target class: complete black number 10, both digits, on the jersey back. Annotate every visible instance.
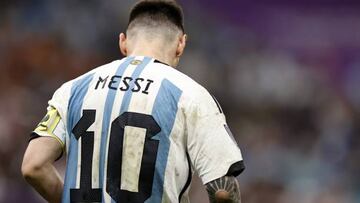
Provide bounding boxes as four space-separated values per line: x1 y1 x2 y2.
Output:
70 110 161 203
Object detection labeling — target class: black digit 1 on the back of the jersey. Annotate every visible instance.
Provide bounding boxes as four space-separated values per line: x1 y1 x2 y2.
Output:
70 110 102 202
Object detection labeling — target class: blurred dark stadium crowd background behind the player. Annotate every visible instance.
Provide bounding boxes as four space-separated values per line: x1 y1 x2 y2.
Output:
0 0 360 203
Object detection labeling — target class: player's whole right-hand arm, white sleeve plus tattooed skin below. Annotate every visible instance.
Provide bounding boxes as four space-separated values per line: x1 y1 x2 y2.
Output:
187 94 245 203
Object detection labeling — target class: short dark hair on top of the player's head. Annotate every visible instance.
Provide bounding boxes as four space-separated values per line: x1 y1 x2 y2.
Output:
128 0 184 32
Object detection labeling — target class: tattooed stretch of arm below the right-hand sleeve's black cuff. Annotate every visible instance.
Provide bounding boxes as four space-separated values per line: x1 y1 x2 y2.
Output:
206 176 241 203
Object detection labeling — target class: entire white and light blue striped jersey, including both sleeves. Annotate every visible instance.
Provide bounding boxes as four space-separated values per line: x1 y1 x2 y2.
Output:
34 56 242 203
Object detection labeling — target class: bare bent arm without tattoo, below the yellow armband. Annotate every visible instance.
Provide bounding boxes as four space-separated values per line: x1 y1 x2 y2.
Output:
21 137 63 203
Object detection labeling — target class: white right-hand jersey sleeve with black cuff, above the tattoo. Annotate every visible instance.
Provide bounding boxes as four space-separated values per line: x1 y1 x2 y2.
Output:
187 92 244 184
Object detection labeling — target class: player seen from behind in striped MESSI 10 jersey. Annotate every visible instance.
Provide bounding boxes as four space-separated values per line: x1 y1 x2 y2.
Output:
22 1 244 203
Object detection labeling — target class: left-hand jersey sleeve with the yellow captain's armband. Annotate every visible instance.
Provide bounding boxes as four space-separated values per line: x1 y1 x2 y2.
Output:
30 83 70 155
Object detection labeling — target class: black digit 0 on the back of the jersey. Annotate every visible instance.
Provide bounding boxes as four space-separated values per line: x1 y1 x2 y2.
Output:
106 112 160 203
